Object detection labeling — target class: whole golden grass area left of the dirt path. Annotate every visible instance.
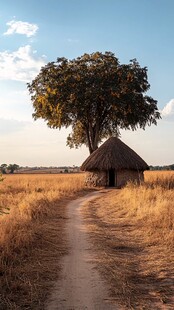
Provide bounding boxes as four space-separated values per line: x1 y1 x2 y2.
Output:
0 174 84 310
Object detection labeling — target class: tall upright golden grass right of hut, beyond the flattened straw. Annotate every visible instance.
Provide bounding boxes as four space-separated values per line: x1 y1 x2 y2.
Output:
116 171 174 248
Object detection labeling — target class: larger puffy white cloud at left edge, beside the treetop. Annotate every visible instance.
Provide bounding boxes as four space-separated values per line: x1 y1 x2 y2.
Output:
0 45 45 82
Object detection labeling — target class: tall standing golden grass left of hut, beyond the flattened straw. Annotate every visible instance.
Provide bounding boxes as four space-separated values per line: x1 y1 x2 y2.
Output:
0 174 84 241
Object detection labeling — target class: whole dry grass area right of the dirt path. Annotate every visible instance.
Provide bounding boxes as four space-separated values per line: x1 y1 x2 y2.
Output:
83 171 174 310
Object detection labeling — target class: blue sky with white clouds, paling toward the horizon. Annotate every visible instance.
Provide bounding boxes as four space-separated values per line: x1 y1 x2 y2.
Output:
0 0 174 166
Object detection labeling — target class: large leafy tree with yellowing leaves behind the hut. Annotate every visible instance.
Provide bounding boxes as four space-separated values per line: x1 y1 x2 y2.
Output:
28 52 160 153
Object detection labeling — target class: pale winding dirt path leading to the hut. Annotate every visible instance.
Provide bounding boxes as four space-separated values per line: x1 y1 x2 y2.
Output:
46 191 117 310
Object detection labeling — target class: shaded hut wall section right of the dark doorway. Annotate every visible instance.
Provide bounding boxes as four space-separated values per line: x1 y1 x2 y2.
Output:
117 169 144 187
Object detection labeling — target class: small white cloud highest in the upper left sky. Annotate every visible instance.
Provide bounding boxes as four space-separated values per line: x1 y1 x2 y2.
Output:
4 20 38 38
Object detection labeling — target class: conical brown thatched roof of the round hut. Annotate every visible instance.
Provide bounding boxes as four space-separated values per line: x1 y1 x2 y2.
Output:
81 137 149 171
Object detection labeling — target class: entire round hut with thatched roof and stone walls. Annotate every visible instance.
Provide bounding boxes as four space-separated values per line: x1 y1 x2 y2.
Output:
81 137 149 188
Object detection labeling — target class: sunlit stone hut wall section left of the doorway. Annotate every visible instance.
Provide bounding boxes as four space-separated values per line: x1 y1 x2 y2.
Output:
85 171 107 186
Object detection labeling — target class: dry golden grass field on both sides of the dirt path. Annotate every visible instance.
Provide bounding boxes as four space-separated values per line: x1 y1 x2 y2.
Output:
0 171 174 310
